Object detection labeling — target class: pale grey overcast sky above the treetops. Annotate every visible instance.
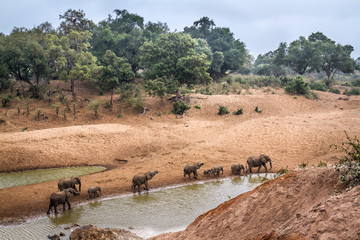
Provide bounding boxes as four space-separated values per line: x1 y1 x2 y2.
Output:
0 0 360 58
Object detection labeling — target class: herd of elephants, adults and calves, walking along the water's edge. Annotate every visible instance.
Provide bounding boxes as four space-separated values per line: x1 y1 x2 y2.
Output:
47 154 272 214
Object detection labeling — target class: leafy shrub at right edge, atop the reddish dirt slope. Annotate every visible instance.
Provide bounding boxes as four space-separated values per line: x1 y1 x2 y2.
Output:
335 132 360 188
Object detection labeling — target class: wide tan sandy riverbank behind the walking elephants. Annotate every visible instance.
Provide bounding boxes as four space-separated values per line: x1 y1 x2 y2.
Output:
0 90 360 232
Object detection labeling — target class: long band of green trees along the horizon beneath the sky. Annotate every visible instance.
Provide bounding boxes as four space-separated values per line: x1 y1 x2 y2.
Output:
0 9 359 100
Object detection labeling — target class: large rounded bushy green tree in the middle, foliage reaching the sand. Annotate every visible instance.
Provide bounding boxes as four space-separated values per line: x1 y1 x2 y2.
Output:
140 33 211 97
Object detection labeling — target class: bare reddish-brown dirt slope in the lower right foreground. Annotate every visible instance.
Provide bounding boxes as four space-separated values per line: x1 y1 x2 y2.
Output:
152 168 360 240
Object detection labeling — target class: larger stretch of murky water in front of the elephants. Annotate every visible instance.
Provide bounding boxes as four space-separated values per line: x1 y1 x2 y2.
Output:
0 174 274 239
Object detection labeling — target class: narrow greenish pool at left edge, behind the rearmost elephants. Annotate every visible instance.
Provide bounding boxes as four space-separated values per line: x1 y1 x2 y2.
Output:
0 166 105 189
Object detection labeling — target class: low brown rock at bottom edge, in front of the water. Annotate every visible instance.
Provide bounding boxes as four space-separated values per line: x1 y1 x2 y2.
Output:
70 225 142 240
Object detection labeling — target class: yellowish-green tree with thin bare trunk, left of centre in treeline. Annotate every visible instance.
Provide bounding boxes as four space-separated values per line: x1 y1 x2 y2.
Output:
46 30 97 101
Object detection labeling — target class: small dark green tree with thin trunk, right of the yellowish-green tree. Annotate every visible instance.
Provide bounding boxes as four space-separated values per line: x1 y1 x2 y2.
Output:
98 50 135 107
